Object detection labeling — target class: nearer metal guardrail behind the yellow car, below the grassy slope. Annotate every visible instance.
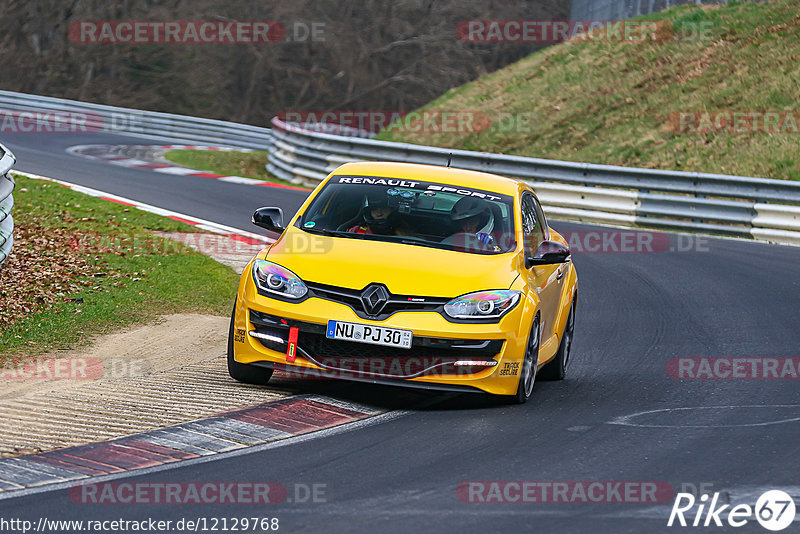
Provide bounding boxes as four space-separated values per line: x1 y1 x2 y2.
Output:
267 118 800 245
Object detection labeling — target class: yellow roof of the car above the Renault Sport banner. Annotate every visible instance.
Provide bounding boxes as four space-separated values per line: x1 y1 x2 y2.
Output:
333 161 520 196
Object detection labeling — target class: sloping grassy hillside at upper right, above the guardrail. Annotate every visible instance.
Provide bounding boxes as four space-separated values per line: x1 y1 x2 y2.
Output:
379 0 800 180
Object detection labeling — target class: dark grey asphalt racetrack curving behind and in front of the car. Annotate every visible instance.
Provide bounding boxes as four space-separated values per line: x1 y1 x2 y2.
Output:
0 134 800 534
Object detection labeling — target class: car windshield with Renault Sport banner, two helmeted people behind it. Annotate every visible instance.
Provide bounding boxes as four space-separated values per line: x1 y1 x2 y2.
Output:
296 176 516 254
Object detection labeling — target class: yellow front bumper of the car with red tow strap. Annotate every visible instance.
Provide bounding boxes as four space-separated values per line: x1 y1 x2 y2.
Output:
234 277 530 395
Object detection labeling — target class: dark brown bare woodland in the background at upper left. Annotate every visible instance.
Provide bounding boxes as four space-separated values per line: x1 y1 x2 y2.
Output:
0 0 569 124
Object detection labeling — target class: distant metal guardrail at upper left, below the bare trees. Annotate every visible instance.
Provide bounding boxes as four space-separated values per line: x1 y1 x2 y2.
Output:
0 91 272 150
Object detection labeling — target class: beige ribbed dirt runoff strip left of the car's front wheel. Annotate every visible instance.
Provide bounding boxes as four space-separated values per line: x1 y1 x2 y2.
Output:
0 314 289 456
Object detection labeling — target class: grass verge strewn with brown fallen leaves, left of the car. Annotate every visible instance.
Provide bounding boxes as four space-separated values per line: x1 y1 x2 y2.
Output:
0 176 238 358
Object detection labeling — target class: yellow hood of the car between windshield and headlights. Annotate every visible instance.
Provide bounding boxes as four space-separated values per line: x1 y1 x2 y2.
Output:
266 227 518 298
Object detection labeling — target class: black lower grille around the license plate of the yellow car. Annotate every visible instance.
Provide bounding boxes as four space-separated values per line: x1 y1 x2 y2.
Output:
250 310 503 378
